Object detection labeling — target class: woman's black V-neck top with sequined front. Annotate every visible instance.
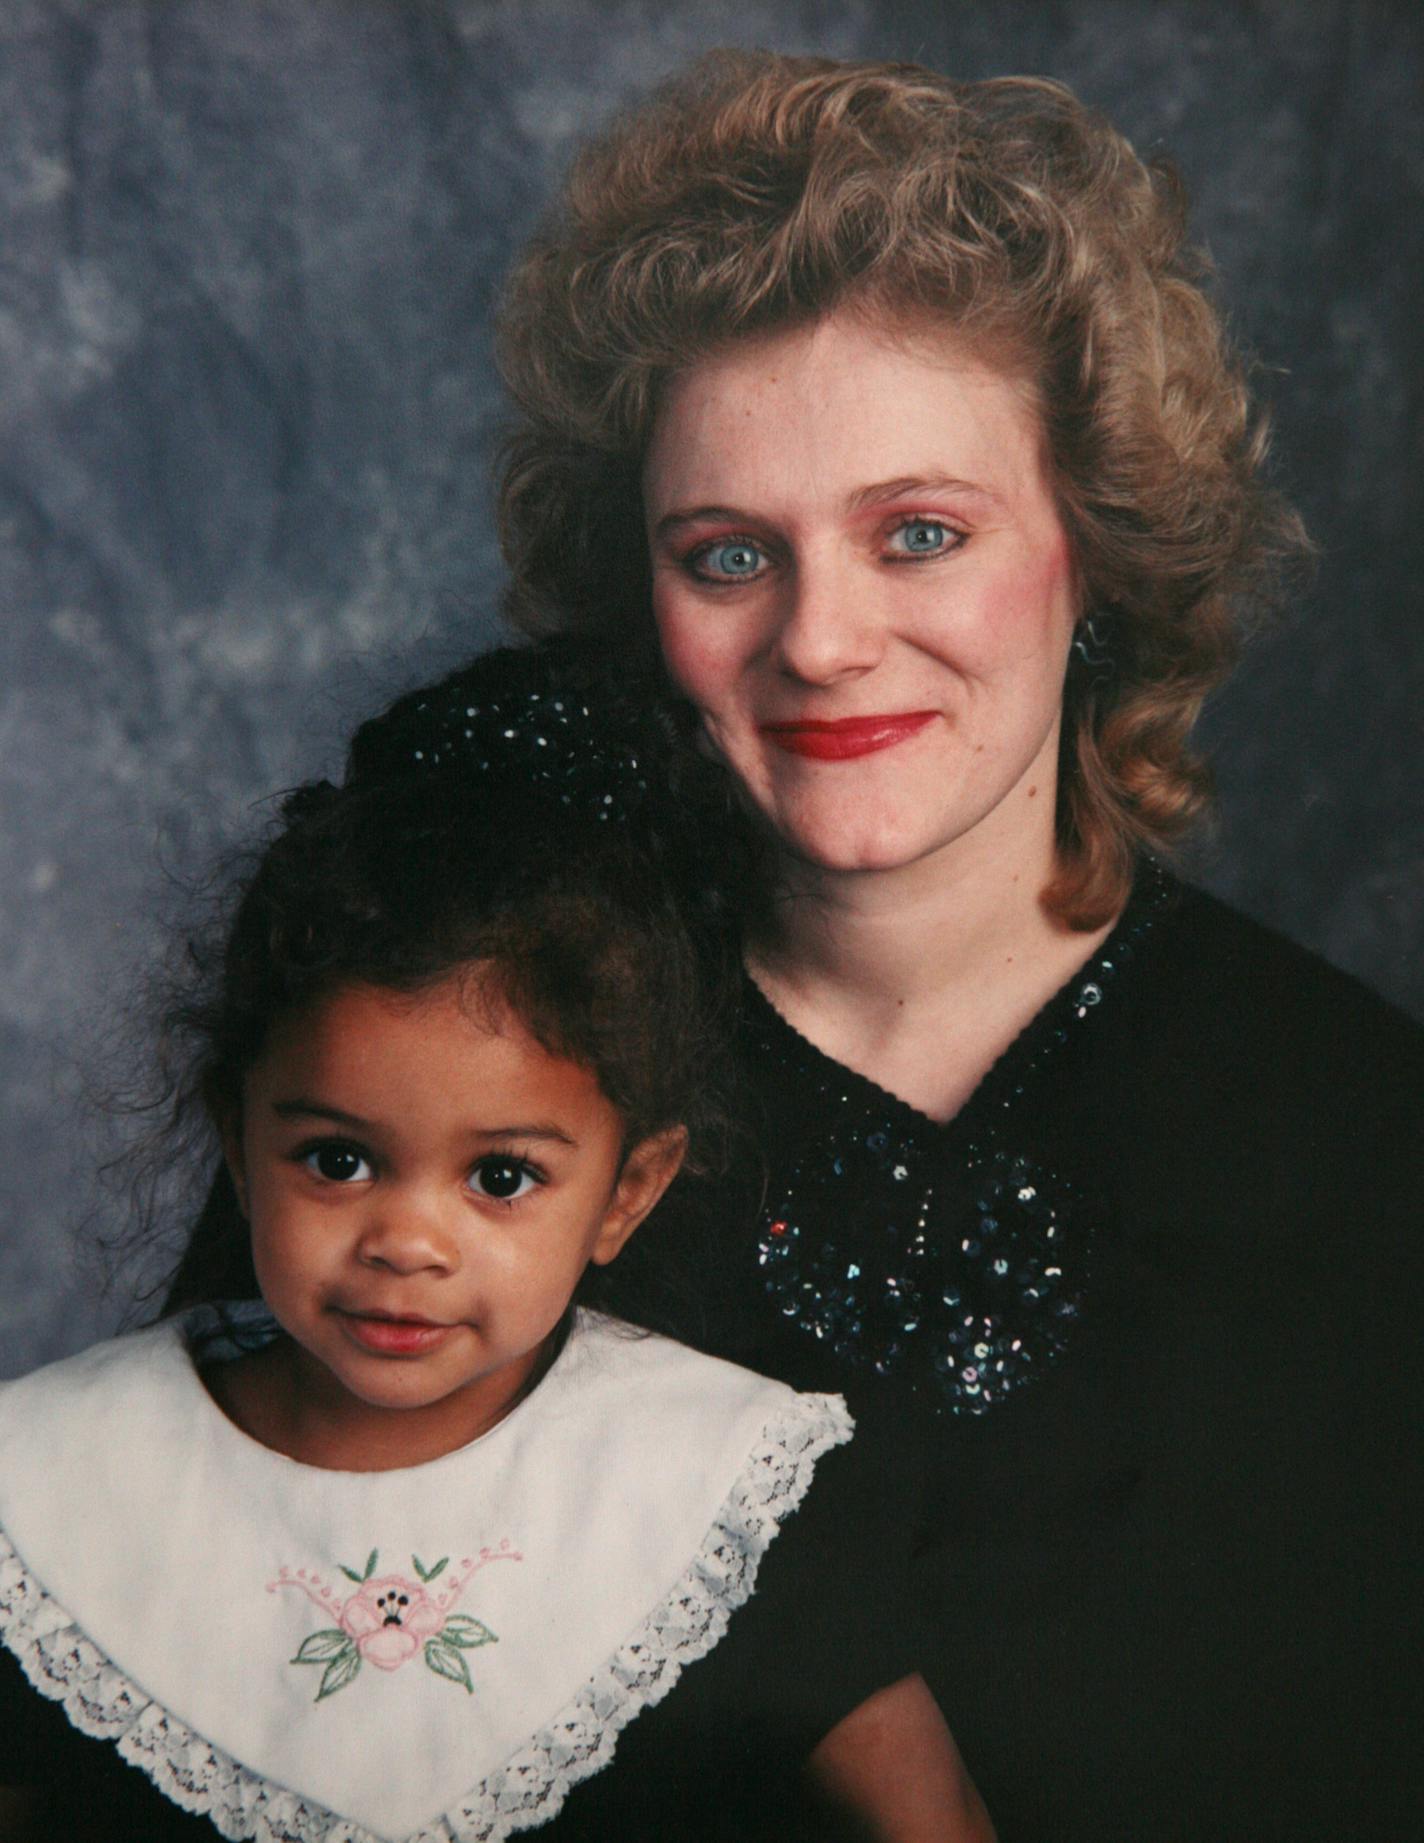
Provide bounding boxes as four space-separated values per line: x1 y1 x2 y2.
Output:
685 880 1424 1843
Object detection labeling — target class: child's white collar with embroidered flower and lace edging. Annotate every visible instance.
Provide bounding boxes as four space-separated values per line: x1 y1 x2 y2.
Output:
0 1314 851 1843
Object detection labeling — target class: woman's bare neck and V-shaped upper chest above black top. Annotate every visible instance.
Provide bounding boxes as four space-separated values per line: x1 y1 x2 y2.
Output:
748 821 1111 1121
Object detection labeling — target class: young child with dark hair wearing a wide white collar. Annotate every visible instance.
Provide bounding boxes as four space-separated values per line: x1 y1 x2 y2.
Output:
0 641 991 1843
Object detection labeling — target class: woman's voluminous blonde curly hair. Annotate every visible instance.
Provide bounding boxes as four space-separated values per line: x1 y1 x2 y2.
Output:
499 52 1308 929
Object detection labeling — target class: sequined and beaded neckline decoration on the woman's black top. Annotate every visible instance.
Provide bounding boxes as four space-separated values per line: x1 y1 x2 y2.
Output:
742 863 1173 1415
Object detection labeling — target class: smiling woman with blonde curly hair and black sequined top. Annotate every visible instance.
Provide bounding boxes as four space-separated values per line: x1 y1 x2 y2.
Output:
364 55 1424 1843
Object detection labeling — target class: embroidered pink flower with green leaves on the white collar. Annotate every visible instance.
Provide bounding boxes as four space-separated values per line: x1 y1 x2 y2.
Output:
267 1537 523 1701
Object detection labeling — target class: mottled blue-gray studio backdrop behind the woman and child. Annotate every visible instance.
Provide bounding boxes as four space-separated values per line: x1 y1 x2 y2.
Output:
0 0 1424 1373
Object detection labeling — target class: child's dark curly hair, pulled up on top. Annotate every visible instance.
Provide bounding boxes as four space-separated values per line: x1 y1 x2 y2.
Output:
150 654 735 1323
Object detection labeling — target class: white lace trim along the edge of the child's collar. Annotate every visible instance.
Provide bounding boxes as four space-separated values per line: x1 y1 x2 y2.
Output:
0 1395 853 1843
